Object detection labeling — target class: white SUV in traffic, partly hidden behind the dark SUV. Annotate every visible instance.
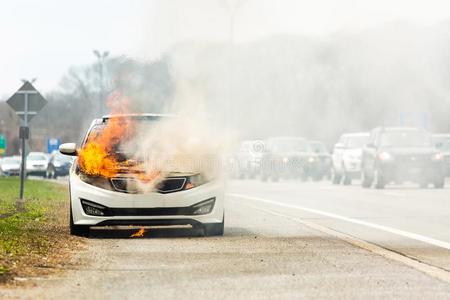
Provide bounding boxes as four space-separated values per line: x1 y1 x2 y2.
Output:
331 132 369 185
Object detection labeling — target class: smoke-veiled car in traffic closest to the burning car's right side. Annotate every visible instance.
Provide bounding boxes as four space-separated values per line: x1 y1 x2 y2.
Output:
232 140 264 178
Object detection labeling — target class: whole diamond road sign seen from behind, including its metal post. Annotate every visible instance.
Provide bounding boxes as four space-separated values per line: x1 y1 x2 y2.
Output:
6 81 47 210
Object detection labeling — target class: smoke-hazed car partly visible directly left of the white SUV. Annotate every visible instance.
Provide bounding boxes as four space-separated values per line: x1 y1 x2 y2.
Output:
308 141 331 180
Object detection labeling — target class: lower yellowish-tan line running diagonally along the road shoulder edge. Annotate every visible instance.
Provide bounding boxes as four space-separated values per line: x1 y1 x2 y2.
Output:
239 199 450 283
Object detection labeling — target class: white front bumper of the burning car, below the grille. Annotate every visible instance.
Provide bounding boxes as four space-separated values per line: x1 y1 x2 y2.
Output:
69 174 224 226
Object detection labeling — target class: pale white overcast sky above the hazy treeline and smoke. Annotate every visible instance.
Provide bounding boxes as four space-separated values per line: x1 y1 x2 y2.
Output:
0 0 450 97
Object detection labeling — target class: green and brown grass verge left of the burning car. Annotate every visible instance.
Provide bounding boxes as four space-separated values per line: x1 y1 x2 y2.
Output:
0 178 82 283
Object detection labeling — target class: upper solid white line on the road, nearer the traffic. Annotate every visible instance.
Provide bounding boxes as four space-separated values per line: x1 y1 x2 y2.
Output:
227 193 450 250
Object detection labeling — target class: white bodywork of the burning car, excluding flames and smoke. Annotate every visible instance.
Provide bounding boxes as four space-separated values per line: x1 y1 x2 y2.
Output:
59 114 224 236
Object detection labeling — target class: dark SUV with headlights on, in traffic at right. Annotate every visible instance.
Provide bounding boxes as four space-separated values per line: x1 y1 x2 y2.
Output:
362 127 445 189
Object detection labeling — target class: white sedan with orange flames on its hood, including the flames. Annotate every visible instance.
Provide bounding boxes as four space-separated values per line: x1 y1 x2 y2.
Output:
60 114 224 236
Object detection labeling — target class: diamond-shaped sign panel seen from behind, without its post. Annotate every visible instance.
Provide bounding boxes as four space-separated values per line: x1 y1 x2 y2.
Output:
6 81 47 126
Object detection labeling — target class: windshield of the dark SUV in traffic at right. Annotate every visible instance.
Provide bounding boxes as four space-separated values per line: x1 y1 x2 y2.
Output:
380 131 432 147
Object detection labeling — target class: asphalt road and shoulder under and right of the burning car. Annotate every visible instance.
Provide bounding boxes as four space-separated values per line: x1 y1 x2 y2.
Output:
0 180 450 299
